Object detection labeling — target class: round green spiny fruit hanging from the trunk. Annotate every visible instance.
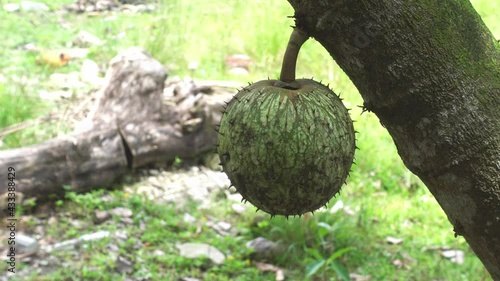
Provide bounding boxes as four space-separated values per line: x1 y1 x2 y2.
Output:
218 79 356 216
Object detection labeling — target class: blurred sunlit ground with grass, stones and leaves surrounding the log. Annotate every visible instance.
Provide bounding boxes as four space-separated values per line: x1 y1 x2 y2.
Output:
0 0 500 281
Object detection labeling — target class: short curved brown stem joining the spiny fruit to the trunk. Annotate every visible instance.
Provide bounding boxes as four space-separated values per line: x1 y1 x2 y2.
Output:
280 28 309 83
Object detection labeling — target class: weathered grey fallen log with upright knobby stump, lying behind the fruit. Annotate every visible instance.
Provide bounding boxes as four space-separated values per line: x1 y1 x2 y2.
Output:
0 48 231 202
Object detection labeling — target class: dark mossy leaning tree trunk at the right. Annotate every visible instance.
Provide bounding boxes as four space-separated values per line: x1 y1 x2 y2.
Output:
289 0 500 280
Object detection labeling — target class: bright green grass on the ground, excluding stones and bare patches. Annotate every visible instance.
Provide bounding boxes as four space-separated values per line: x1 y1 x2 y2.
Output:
0 0 500 281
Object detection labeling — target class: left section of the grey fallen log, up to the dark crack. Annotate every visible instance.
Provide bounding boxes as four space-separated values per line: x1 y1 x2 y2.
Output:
0 129 127 199
